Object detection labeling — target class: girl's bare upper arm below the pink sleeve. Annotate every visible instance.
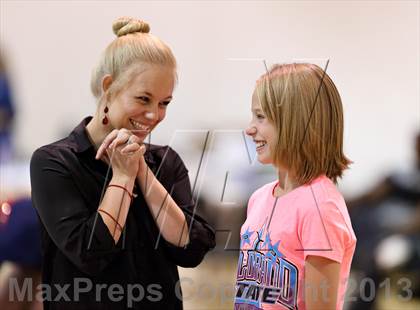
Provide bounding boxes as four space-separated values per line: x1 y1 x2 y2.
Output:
305 255 340 310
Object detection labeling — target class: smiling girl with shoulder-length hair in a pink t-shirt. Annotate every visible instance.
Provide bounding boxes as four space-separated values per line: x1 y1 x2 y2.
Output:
235 64 356 310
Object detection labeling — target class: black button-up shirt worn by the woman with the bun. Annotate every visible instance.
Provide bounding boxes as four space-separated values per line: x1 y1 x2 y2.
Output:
30 118 215 310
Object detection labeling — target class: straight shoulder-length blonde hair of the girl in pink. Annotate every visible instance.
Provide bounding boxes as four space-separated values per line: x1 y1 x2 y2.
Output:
256 63 351 185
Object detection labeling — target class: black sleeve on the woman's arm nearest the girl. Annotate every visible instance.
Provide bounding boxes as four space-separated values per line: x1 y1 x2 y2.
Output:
160 149 216 267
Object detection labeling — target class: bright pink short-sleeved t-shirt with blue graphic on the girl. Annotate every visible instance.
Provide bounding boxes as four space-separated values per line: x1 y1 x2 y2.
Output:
235 176 356 310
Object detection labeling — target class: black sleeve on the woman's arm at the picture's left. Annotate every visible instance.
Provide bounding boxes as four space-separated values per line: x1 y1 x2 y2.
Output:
30 148 120 276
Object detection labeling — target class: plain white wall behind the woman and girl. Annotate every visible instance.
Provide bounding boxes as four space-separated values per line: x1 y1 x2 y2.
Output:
0 0 420 193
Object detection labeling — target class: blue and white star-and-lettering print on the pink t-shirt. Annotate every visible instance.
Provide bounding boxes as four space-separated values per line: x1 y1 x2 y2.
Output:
235 218 298 310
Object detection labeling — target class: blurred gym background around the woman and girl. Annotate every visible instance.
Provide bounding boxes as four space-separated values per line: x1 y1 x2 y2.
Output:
0 0 420 310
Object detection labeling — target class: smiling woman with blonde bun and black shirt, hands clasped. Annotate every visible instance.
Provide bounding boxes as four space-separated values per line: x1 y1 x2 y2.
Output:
31 18 214 309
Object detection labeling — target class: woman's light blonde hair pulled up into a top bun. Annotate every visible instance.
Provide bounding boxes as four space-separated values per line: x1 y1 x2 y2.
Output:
90 17 176 99
